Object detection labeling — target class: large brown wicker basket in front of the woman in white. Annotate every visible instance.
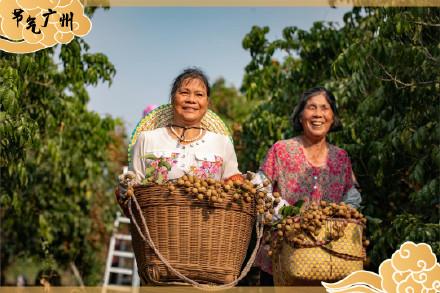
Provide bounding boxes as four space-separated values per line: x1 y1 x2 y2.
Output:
131 185 256 284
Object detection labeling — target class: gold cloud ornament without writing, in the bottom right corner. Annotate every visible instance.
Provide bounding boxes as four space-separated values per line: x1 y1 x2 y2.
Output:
322 241 440 293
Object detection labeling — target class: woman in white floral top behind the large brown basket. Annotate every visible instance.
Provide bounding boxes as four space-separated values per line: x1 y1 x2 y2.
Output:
129 68 241 182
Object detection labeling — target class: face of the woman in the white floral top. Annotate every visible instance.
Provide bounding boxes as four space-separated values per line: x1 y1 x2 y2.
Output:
173 78 208 126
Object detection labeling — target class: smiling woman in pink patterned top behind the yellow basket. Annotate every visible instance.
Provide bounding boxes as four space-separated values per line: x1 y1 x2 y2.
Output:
256 87 361 285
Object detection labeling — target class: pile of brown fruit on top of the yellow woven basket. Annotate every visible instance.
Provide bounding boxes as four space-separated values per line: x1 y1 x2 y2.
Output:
265 201 369 255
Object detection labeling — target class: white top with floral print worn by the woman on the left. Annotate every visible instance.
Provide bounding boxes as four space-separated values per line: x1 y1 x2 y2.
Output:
129 128 240 182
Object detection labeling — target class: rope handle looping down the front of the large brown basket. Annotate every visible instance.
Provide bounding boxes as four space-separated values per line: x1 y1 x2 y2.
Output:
128 196 263 291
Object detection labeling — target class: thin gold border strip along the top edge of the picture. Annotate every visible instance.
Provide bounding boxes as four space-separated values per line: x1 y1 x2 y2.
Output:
82 0 440 7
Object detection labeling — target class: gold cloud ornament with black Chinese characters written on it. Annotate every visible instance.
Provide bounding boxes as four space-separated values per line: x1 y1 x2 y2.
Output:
0 0 92 53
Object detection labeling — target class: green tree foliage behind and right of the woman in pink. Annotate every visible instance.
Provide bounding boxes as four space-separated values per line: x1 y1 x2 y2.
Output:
241 8 440 267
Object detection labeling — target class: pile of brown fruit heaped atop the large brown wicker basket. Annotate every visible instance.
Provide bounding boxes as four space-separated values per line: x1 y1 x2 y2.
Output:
166 174 281 224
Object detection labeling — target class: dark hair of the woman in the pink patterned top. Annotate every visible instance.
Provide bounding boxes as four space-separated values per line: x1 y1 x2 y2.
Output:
292 86 342 132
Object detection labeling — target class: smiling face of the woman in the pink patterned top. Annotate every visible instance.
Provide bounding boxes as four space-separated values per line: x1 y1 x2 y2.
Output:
300 94 334 139
